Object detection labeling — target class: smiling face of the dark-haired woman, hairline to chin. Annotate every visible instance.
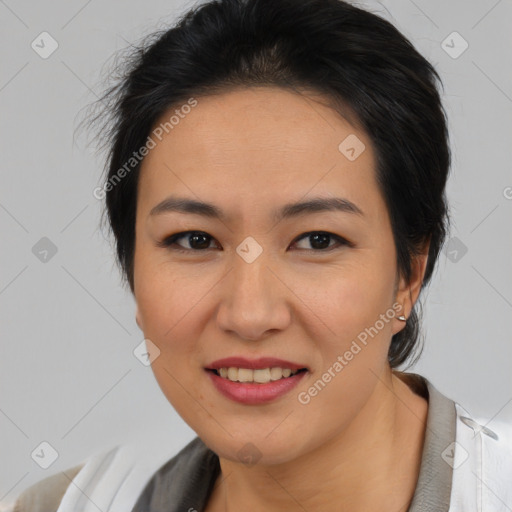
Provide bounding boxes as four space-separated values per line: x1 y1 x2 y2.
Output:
134 87 407 464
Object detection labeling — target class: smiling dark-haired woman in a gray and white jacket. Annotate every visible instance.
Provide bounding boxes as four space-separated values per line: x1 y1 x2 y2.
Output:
12 0 512 512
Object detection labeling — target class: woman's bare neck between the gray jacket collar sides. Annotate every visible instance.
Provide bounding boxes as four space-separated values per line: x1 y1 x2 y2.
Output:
207 367 428 512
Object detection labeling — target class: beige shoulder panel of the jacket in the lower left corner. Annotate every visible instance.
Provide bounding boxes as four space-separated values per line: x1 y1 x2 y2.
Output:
13 462 85 512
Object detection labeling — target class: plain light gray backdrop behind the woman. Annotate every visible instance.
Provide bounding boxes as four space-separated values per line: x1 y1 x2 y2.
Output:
0 0 512 510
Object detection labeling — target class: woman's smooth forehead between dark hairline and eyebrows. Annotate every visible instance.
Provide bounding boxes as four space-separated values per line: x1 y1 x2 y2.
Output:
139 87 384 223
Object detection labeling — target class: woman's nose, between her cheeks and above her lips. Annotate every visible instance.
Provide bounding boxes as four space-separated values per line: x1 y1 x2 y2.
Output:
217 255 292 341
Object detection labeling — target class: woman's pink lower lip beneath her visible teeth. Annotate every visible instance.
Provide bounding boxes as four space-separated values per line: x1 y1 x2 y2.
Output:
206 368 308 405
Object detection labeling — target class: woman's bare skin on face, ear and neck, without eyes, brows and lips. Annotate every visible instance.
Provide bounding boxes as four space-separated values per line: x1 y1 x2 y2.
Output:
134 87 428 512
